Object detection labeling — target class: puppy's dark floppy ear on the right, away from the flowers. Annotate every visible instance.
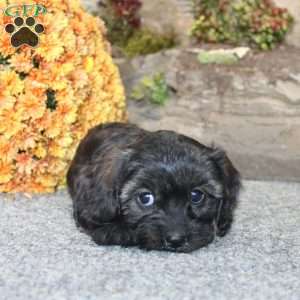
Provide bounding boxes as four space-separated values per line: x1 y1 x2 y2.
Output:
212 148 241 236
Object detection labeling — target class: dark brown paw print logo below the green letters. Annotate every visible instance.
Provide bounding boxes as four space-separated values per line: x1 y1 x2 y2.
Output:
5 17 45 48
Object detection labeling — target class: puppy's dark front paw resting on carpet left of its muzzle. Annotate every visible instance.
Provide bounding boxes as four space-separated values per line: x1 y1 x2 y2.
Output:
91 223 136 247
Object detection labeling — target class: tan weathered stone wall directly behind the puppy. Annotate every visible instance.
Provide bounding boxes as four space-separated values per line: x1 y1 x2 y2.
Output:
119 47 300 181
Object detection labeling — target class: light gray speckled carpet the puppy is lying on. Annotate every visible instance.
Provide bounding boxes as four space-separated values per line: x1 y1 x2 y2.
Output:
0 182 300 300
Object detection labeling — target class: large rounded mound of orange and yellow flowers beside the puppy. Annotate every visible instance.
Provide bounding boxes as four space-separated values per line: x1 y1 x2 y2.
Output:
0 0 126 193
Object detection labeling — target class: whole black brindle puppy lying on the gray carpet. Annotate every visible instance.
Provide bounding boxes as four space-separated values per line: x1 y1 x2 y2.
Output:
67 123 240 252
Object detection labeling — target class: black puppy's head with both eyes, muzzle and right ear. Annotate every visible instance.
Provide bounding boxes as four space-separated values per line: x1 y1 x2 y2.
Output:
118 131 240 252
